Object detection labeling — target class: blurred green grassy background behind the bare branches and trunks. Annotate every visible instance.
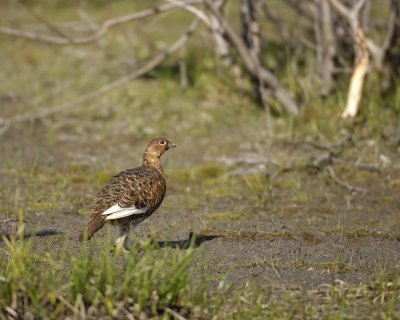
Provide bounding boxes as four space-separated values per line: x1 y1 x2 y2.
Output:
0 0 400 132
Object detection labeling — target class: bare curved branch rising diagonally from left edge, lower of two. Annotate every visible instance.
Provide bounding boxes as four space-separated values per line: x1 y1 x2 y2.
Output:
0 18 199 135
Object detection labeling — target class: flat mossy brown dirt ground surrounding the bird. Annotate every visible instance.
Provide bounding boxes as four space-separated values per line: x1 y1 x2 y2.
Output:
0 115 400 289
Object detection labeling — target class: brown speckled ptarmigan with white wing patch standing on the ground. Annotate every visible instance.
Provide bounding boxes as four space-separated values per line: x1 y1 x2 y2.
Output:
80 138 175 249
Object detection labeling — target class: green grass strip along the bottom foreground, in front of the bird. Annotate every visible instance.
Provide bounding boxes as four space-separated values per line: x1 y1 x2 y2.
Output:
0 225 400 319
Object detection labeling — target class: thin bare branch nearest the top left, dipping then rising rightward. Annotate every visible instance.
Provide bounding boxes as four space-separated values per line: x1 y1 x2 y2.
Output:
0 0 202 45
